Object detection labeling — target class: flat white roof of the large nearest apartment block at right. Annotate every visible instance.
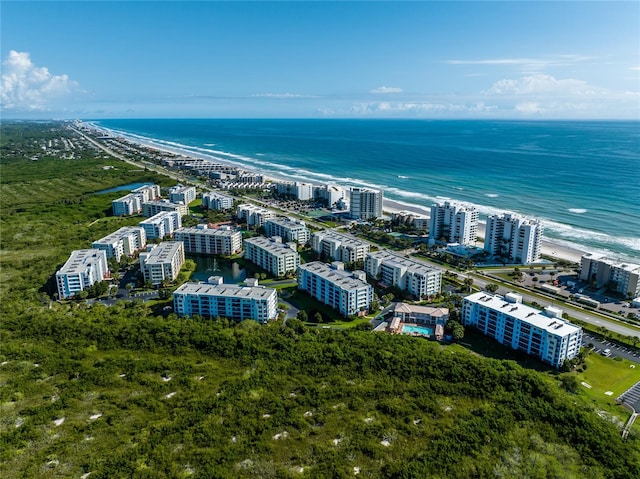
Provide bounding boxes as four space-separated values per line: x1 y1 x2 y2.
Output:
464 291 582 336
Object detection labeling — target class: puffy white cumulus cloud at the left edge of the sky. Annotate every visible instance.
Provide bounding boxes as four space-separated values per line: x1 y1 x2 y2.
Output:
0 50 79 111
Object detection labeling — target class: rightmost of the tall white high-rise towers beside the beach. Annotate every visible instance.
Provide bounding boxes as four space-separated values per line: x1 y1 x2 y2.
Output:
484 213 543 264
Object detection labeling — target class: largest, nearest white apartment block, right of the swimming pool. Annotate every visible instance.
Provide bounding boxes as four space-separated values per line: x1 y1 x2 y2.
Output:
462 292 582 368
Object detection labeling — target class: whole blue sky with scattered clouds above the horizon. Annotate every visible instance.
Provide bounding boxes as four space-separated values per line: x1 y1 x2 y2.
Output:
0 0 640 119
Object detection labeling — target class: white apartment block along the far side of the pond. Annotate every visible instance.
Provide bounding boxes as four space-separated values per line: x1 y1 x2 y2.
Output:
174 225 242 256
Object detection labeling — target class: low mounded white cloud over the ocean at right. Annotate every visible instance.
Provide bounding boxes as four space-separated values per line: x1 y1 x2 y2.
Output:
483 74 603 96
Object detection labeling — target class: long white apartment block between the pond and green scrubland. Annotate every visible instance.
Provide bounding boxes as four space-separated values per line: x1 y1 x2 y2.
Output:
173 276 278 323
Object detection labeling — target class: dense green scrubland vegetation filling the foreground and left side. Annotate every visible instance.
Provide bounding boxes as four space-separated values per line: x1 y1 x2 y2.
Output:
0 126 640 479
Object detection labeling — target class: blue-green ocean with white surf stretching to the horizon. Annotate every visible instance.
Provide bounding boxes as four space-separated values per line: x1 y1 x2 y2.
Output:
92 119 640 261
